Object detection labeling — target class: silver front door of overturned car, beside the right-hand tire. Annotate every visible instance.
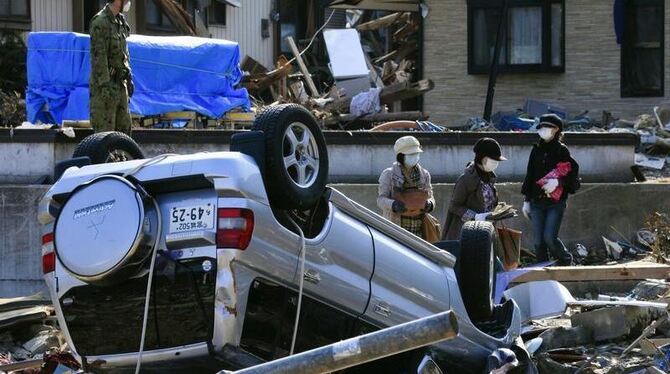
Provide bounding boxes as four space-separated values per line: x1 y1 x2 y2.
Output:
364 229 450 326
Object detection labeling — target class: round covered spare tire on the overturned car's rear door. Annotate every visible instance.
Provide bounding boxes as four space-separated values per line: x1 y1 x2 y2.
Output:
54 175 158 285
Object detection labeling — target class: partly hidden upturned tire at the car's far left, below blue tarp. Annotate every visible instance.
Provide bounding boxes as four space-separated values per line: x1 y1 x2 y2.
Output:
72 131 144 164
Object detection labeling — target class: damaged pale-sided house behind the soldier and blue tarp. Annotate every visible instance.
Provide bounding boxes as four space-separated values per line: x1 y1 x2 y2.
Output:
0 0 275 66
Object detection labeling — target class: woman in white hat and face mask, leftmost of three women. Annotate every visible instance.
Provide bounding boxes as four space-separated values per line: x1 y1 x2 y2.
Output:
377 136 435 239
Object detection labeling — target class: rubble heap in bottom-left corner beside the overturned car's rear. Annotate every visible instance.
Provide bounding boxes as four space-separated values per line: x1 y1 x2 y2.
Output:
0 293 78 373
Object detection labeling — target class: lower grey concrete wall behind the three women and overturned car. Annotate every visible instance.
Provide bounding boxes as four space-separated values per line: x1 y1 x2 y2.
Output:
0 183 670 298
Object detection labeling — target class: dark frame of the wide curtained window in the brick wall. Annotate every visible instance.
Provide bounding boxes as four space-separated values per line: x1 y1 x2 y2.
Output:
467 0 565 75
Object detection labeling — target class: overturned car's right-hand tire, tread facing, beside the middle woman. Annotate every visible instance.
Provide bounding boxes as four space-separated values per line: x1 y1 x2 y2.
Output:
457 221 495 322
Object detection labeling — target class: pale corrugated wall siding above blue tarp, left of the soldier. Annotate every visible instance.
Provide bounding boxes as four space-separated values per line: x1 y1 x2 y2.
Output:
30 0 73 31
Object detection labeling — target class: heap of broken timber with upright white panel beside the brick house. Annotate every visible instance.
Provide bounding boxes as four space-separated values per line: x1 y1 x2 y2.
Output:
241 10 444 131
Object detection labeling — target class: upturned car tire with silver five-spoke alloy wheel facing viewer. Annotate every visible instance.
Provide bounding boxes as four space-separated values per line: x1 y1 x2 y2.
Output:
253 104 328 210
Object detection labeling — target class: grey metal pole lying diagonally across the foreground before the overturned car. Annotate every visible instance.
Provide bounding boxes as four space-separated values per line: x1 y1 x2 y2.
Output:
219 311 458 374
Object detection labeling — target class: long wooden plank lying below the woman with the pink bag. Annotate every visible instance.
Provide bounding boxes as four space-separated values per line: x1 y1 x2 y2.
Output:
511 262 670 283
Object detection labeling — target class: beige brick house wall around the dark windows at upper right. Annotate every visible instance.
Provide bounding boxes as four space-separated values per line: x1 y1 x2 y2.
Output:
423 0 670 124
